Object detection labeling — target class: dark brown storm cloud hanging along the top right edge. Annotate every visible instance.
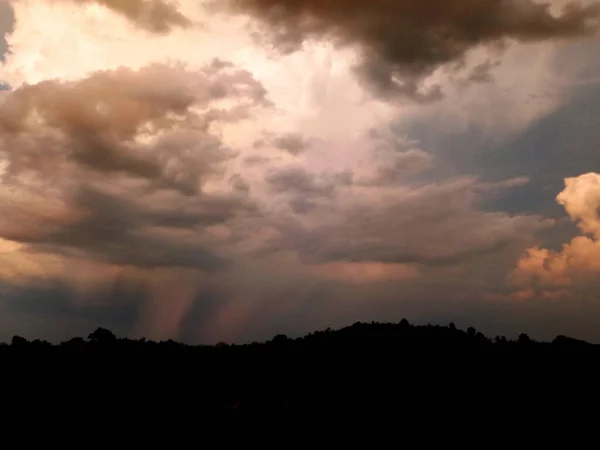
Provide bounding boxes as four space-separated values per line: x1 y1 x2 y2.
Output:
212 0 600 101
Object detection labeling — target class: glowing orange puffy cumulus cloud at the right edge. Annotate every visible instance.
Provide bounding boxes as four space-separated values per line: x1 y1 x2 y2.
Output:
509 173 600 295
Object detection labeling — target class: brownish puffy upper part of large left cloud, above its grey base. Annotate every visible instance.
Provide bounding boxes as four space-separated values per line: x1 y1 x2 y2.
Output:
0 59 265 195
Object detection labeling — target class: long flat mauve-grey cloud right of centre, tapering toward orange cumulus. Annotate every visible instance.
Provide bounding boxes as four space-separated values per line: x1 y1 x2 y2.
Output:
273 179 549 266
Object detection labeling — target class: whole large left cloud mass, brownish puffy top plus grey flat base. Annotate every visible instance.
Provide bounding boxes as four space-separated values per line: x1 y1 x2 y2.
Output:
0 62 264 270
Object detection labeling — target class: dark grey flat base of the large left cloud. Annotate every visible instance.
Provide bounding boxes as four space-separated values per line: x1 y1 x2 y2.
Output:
0 187 254 270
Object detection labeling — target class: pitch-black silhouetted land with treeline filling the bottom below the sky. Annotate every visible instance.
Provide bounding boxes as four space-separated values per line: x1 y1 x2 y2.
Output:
0 321 600 442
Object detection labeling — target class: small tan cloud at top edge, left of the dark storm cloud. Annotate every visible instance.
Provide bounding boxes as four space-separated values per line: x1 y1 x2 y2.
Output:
49 0 192 33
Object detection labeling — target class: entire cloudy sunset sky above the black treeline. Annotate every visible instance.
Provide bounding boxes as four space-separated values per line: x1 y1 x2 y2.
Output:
0 0 600 344
